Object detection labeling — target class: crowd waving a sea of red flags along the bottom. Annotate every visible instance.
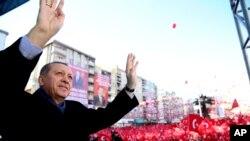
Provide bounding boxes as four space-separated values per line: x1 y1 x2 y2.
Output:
91 114 250 141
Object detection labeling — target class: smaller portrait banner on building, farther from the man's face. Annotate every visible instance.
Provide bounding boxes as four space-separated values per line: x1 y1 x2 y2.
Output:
94 70 110 107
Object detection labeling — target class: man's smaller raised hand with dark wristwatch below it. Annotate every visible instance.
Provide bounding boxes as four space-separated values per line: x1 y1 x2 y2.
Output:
126 53 138 89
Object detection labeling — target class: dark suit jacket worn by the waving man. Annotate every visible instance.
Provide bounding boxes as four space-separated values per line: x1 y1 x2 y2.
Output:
0 39 138 141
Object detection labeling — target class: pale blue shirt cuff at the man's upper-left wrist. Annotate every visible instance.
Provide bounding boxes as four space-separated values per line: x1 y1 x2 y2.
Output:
19 35 43 60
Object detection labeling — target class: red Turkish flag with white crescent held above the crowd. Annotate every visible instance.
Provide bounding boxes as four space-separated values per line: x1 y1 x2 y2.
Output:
188 114 203 132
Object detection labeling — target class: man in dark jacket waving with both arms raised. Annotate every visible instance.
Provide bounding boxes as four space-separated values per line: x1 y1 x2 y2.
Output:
0 0 138 141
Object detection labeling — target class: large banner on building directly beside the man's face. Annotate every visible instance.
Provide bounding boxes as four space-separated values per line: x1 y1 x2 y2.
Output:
67 65 88 105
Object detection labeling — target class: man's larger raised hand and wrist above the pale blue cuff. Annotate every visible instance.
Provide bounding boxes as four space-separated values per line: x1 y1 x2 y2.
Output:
28 0 65 48
